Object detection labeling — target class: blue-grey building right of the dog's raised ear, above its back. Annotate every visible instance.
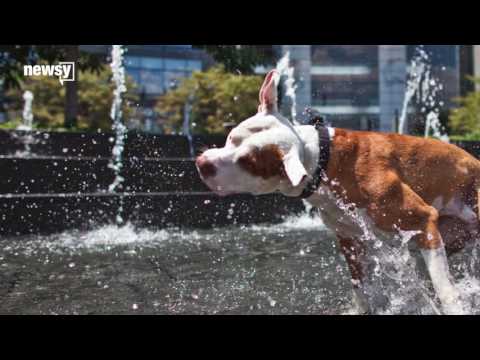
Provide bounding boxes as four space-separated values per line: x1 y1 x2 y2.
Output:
270 45 462 132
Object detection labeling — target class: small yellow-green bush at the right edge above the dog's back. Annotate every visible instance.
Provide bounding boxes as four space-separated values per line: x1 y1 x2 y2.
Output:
449 78 480 139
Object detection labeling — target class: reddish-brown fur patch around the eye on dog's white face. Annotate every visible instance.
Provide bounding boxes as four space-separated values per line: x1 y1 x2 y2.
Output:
238 145 285 179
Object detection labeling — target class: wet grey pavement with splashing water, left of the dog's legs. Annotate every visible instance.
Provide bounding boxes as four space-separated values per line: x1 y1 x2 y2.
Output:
0 215 350 314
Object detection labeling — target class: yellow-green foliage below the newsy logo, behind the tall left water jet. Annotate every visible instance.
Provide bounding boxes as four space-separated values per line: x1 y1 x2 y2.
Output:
6 65 138 130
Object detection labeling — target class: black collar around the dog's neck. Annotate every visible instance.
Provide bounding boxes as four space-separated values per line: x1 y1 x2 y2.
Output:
299 112 330 199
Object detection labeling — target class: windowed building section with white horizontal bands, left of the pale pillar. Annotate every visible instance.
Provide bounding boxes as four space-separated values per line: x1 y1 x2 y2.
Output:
310 45 379 128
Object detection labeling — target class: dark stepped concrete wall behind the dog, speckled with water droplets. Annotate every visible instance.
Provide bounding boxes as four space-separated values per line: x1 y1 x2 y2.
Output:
0 131 303 236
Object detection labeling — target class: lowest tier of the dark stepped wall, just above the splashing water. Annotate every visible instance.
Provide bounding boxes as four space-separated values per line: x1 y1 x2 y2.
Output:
0 193 304 235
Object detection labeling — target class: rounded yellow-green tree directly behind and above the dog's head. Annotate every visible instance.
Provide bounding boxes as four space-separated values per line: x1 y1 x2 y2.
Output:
155 65 262 134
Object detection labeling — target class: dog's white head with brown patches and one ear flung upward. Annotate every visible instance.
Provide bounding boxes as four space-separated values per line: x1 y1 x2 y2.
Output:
196 70 307 195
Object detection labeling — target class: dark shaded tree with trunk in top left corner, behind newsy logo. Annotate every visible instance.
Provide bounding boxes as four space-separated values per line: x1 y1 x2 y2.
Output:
0 45 103 128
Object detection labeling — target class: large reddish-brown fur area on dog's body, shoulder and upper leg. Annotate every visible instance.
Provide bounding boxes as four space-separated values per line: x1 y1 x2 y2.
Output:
327 129 480 249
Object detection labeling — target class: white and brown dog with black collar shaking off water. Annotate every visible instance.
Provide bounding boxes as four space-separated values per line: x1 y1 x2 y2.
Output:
196 71 480 314
